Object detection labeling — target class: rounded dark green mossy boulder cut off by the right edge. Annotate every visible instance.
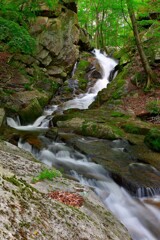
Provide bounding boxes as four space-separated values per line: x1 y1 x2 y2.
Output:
144 128 160 152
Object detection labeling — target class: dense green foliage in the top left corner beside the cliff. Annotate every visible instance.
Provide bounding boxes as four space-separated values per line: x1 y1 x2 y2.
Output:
0 0 57 54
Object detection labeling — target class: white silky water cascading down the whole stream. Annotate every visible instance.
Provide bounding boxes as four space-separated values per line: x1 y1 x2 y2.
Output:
8 50 160 240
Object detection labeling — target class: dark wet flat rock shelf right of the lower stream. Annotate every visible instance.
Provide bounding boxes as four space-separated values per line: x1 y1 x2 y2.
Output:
59 132 160 197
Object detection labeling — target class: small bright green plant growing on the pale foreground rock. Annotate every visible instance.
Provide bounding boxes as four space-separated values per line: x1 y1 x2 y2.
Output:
32 168 62 183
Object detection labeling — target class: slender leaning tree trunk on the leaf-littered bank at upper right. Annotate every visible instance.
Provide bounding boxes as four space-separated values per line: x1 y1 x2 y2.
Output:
126 0 156 88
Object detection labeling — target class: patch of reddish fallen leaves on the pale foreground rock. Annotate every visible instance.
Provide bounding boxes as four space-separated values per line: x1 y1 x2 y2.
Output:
48 191 84 207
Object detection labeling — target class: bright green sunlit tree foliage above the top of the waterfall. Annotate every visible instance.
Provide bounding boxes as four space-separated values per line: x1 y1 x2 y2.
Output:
78 0 160 48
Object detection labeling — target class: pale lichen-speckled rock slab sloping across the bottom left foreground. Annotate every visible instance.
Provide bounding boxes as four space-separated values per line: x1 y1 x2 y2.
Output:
0 142 131 240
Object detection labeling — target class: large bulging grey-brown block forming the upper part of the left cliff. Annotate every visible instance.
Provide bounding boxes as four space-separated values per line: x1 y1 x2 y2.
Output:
33 9 79 72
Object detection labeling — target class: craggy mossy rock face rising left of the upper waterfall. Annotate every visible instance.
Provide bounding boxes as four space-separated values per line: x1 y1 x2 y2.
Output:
0 1 90 124
